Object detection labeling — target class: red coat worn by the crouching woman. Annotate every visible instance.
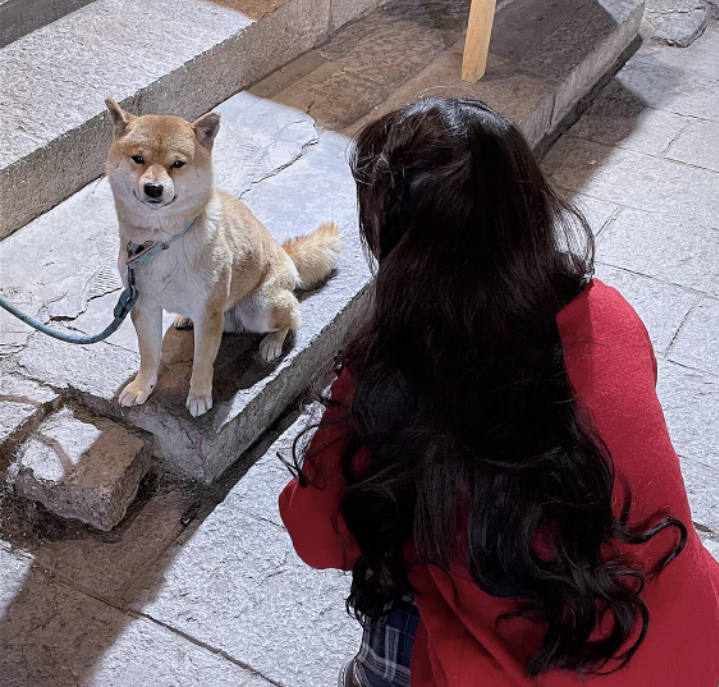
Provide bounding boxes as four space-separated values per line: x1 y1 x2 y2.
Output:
280 280 719 687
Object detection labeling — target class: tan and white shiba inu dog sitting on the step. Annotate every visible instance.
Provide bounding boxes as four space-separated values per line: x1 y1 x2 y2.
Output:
105 98 341 417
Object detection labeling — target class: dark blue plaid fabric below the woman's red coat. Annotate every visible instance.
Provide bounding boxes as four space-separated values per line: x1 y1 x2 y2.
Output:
354 596 419 687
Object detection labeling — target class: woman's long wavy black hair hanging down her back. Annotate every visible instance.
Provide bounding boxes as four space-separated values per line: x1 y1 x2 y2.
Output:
295 99 686 676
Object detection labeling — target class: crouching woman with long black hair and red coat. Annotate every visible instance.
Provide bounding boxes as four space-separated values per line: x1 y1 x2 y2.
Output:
280 99 719 687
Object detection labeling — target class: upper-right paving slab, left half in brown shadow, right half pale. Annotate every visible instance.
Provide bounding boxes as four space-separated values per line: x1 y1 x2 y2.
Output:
569 77 690 159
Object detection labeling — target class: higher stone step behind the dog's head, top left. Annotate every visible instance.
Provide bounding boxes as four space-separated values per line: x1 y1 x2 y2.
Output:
0 0 388 239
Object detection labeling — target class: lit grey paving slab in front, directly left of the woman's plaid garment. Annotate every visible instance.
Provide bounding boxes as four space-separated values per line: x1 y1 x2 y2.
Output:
122 408 361 687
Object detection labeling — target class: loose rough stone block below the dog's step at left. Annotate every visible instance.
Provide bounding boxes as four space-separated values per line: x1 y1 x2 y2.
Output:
12 407 150 531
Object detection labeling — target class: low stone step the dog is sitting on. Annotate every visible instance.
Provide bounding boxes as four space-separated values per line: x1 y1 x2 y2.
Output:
0 0 642 481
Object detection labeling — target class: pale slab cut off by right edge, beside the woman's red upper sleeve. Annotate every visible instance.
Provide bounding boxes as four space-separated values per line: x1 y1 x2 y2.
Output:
669 298 719 376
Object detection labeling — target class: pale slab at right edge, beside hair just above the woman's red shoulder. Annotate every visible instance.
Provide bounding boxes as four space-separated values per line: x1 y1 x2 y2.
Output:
597 208 719 296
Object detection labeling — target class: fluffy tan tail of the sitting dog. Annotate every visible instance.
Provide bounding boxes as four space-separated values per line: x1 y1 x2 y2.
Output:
282 222 342 289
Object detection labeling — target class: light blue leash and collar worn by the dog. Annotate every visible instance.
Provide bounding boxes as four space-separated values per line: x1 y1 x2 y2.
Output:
0 219 195 345
